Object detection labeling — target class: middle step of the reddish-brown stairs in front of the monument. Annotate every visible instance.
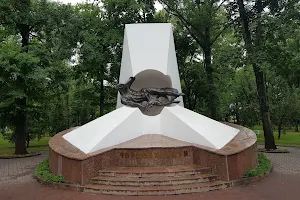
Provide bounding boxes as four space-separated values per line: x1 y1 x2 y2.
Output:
91 174 219 186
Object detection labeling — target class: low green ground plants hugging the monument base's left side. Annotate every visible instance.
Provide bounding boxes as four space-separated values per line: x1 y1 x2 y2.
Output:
35 158 68 183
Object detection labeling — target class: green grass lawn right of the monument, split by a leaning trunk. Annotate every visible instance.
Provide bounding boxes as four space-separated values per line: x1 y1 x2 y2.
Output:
252 126 300 146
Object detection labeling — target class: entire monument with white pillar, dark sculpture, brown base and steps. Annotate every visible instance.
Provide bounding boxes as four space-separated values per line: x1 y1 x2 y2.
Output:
49 23 257 195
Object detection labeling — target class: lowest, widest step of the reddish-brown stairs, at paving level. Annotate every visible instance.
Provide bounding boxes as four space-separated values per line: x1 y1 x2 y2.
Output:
84 181 230 196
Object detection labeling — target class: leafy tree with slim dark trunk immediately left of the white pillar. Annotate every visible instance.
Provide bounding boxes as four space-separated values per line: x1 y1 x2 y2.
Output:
75 0 155 116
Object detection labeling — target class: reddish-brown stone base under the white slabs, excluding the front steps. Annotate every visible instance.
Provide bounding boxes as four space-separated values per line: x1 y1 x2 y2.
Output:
49 125 257 185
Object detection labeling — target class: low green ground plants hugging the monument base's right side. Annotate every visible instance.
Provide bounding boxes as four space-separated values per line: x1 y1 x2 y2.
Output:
243 153 271 178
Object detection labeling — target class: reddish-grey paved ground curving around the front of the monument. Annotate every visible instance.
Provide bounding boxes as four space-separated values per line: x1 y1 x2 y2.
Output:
0 148 300 200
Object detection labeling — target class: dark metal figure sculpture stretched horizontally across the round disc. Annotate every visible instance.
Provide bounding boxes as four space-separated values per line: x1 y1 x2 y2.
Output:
117 77 184 111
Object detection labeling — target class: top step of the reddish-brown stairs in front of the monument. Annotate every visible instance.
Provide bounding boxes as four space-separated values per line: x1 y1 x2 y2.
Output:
99 165 212 178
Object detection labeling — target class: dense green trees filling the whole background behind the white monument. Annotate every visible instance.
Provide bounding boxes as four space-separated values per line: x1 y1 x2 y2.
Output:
0 0 300 154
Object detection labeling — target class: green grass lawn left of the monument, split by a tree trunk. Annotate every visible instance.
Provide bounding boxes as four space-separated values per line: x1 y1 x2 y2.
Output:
0 135 50 154
